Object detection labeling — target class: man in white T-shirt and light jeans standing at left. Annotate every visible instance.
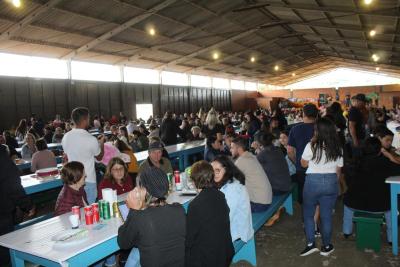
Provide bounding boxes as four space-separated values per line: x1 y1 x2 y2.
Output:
61 107 104 204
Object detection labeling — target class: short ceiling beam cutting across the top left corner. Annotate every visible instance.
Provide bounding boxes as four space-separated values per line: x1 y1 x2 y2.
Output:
0 0 62 41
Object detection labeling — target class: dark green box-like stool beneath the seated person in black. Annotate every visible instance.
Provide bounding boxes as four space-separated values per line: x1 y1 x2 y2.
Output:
353 211 383 252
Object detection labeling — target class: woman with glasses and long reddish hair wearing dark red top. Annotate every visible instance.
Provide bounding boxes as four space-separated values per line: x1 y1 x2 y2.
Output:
97 158 133 199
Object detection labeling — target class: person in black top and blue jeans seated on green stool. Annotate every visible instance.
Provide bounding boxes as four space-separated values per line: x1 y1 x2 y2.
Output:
343 137 400 243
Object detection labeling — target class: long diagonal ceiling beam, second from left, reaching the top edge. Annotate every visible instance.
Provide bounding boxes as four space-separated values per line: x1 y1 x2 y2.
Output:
62 0 176 59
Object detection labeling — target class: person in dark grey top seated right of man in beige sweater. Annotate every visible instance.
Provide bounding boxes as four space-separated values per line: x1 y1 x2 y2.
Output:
257 133 292 195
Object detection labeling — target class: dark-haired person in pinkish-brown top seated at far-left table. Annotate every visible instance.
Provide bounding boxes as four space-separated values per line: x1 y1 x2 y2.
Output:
31 138 57 172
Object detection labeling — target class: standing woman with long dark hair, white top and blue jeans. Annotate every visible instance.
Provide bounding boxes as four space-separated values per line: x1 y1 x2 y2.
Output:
300 118 343 256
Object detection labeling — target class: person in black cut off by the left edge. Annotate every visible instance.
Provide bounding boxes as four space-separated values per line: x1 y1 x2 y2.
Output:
0 145 35 266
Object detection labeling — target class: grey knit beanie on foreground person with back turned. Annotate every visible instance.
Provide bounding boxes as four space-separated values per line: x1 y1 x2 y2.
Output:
139 167 169 198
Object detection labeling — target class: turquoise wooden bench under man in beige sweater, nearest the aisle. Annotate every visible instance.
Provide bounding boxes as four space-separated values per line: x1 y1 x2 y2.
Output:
232 185 294 266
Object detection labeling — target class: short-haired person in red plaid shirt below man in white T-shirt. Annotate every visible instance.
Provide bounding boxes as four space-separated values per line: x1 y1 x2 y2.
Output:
54 161 88 216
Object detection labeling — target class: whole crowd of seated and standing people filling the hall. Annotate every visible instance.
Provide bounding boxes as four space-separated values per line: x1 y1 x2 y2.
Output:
0 94 400 266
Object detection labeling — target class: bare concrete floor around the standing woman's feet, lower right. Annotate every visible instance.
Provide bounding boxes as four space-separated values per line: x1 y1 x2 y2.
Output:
232 201 400 267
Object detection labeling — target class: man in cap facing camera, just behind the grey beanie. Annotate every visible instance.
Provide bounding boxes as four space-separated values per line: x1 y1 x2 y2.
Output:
139 142 173 173
